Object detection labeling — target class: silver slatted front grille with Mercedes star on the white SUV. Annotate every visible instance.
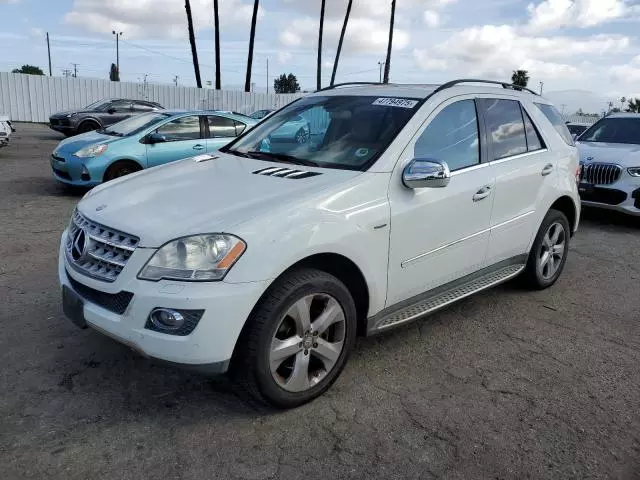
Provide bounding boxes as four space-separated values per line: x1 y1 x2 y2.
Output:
65 210 140 282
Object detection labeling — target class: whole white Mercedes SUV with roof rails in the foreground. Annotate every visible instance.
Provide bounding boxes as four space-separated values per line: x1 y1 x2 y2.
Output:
59 80 580 407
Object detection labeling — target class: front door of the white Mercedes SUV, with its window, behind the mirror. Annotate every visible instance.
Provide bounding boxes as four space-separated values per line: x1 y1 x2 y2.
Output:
387 97 494 307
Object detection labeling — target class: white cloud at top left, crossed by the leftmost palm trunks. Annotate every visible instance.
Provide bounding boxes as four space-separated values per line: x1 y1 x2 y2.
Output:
64 0 264 38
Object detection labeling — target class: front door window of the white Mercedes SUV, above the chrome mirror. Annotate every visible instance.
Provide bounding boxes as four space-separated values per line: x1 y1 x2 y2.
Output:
414 100 480 170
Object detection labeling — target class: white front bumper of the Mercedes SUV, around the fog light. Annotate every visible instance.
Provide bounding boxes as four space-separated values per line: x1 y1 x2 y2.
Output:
58 231 268 373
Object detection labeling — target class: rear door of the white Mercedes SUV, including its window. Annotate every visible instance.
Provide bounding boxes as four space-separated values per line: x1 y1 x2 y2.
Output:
478 98 556 265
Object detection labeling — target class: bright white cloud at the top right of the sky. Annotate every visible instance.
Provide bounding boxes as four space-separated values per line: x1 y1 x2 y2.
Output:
527 0 635 32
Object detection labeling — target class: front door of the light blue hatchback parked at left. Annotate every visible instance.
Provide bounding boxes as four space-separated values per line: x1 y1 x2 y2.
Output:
147 115 207 167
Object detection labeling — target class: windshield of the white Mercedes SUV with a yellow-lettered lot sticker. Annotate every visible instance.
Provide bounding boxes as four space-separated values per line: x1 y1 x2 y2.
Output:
221 95 421 170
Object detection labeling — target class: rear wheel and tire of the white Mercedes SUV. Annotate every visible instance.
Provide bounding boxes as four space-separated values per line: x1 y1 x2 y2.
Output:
523 210 571 290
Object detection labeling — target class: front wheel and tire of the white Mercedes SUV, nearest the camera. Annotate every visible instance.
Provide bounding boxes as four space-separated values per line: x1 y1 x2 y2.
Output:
231 269 357 408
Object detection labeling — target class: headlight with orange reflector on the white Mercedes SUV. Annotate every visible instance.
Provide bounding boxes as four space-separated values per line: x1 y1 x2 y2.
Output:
138 233 247 281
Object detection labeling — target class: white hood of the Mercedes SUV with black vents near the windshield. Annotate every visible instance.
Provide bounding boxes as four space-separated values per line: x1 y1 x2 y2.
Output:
78 153 362 248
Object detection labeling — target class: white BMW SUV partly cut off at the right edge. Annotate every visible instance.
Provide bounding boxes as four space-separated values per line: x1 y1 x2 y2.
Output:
577 113 640 215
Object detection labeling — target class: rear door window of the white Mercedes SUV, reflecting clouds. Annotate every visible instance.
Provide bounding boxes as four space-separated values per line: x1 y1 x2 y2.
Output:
484 99 527 160
